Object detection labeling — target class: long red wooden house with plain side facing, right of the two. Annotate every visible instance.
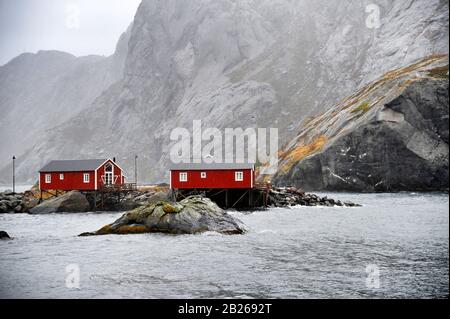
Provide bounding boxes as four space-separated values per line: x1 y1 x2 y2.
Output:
170 164 256 190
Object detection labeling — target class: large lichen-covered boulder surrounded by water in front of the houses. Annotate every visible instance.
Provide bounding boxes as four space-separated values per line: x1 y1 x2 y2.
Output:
80 196 246 236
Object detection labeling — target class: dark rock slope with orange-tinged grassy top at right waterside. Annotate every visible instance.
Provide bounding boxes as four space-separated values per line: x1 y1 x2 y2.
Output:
274 56 449 192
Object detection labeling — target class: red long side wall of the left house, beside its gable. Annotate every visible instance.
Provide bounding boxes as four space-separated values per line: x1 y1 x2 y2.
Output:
40 172 95 191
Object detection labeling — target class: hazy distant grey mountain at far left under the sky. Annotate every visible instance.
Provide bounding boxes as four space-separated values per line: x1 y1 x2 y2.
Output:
0 26 132 178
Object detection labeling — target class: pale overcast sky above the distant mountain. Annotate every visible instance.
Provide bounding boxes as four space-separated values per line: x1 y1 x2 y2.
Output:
0 0 141 65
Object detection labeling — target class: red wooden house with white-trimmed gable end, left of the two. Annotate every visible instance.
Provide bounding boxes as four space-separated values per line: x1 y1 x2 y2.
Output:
39 159 125 191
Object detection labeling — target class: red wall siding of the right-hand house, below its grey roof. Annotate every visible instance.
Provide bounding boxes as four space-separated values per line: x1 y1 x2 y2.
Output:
171 169 254 189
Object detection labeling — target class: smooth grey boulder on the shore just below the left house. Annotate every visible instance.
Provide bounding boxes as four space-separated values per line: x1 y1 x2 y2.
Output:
30 191 91 214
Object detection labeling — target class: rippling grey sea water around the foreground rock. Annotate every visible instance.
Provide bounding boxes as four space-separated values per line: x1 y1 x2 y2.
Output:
0 193 449 298
